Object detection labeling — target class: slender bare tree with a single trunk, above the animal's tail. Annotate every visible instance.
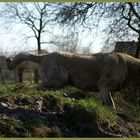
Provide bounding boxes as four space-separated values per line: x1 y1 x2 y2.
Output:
4 2 53 53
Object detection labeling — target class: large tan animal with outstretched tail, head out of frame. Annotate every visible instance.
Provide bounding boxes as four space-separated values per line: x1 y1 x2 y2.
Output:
7 52 140 106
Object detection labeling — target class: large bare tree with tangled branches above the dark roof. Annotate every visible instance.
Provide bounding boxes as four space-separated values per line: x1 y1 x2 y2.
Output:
56 2 140 53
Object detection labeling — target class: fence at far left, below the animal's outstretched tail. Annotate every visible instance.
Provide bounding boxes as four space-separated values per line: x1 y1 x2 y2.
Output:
0 50 43 84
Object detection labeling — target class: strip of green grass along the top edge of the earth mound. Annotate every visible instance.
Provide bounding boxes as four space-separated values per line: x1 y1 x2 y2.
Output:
0 83 116 122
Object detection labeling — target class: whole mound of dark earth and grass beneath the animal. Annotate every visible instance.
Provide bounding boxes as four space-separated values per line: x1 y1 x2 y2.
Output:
0 84 140 137
